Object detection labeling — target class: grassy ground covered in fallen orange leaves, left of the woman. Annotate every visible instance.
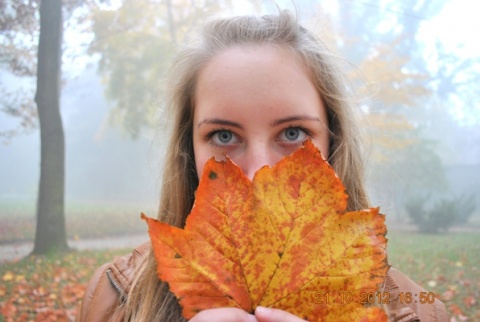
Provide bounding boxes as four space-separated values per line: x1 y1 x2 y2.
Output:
0 249 128 322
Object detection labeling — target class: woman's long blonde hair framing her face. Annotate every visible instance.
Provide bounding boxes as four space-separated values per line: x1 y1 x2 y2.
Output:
125 11 368 321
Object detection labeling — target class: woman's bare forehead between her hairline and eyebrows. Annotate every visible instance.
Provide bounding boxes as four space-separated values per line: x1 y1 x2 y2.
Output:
194 45 319 116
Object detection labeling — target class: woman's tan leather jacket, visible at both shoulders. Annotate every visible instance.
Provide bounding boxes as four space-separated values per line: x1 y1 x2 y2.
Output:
76 243 448 322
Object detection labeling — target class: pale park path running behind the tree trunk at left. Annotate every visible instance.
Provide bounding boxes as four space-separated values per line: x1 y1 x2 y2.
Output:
0 233 149 264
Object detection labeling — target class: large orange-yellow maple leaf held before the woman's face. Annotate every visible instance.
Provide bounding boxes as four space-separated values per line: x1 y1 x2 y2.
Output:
142 141 388 321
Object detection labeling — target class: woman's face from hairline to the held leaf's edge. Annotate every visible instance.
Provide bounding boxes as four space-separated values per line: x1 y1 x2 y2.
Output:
193 45 329 179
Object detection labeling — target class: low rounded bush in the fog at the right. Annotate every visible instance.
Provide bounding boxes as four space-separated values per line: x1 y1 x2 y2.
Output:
405 194 475 233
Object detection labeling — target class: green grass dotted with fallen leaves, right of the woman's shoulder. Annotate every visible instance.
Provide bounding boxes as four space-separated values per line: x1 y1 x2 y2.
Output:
387 232 480 321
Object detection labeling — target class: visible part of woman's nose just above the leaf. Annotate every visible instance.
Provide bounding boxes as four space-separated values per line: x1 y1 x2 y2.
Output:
242 141 277 180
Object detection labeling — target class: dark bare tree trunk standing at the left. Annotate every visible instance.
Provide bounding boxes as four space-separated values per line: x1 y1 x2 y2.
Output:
33 0 68 254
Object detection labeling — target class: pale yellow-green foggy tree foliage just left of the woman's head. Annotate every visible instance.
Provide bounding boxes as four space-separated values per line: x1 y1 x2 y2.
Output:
90 0 237 138
